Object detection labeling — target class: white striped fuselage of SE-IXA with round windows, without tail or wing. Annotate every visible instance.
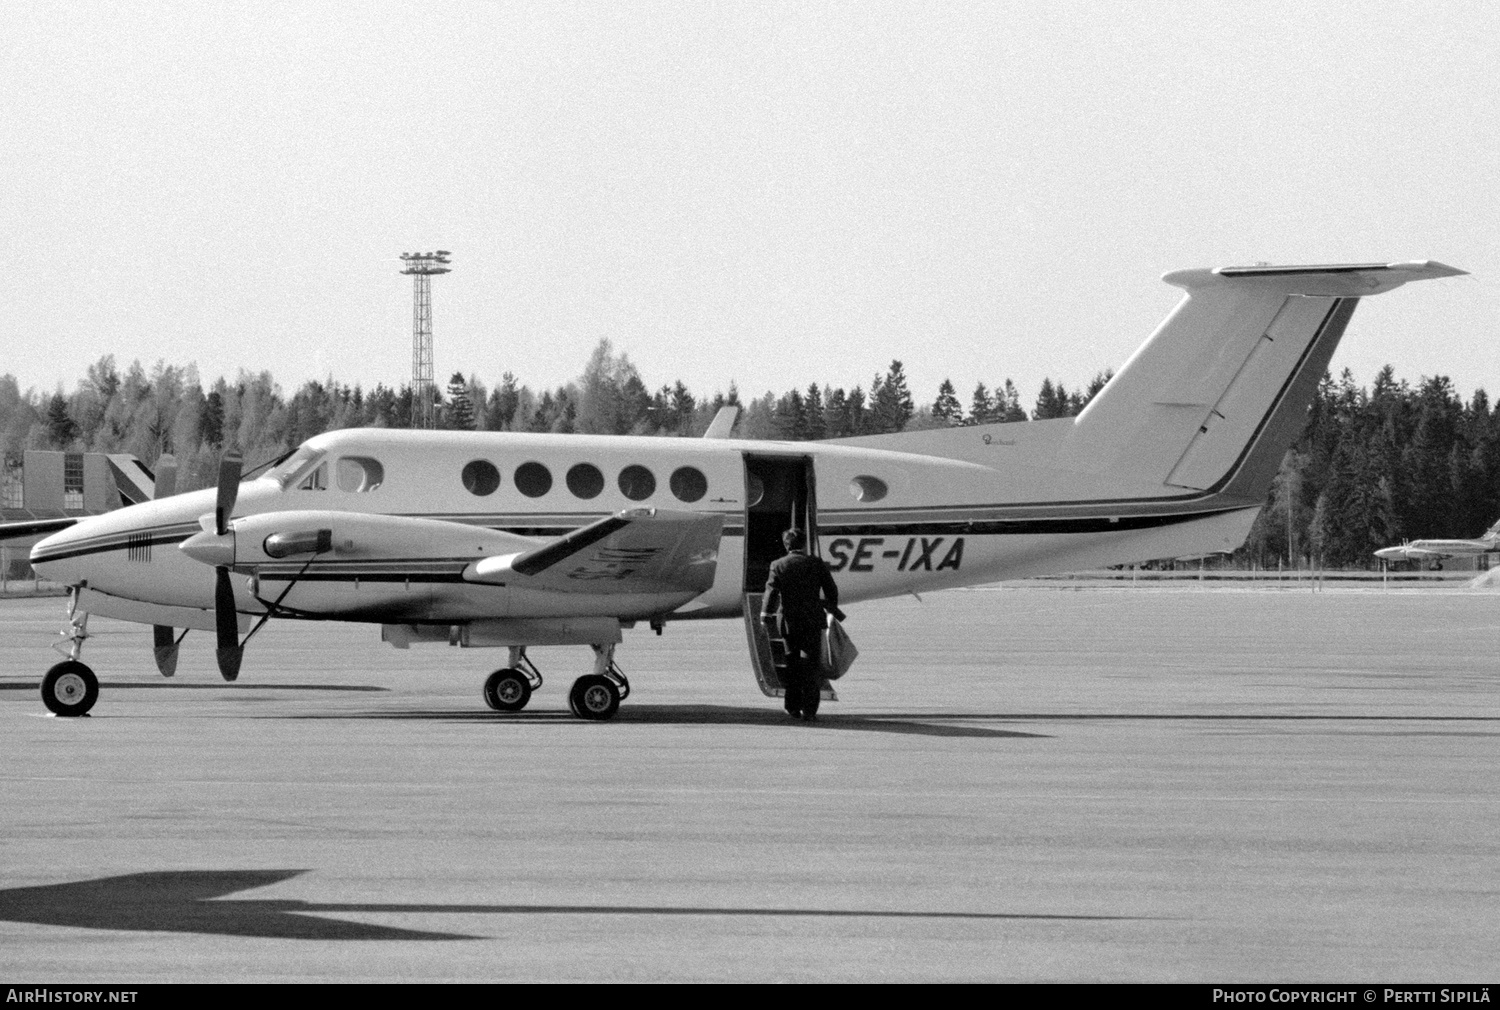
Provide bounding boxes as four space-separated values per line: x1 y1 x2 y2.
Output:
33 422 1256 627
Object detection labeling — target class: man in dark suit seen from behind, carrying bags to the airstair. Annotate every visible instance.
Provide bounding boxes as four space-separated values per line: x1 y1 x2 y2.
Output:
761 528 843 722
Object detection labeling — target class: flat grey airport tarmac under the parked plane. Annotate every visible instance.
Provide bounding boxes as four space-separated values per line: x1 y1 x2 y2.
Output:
0 587 1500 984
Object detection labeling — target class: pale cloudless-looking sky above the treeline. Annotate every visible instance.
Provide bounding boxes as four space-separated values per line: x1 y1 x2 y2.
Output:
0 0 1500 404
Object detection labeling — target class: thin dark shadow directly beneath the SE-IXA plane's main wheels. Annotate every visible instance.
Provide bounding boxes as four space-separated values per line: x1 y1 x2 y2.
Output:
283 704 1049 740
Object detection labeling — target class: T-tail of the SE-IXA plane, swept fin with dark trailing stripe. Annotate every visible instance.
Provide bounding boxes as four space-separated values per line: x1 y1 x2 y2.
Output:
1055 261 1464 501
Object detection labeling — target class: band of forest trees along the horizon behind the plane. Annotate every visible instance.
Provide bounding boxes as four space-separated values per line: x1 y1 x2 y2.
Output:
0 341 1500 569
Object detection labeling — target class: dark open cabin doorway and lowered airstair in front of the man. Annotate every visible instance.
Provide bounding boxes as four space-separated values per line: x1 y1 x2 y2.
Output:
744 453 839 701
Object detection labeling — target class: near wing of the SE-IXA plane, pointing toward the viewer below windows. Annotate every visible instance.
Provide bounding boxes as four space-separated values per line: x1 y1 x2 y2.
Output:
464 509 725 594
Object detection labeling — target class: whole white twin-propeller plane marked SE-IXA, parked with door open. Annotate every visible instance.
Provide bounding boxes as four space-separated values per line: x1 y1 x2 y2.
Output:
11 261 1464 719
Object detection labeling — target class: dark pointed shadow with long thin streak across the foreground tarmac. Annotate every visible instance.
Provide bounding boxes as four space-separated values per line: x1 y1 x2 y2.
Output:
0 870 1143 939
